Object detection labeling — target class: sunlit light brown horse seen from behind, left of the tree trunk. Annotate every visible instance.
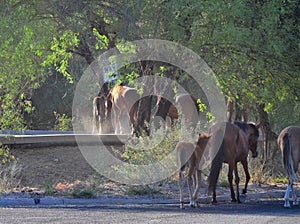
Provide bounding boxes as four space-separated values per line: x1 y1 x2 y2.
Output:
107 85 139 134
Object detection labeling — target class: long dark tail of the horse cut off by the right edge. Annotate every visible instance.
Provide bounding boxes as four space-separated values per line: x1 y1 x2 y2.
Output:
282 133 298 183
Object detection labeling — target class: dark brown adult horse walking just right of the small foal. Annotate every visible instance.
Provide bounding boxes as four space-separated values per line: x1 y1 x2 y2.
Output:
208 122 259 203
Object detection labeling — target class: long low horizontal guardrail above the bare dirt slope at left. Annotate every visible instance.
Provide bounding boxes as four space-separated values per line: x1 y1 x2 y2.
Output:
0 133 129 146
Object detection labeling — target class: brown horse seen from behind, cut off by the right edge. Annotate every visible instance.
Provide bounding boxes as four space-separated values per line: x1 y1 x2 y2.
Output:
277 126 300 208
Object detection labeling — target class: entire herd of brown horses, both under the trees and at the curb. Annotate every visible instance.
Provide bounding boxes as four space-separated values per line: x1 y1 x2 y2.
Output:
93 85 300 208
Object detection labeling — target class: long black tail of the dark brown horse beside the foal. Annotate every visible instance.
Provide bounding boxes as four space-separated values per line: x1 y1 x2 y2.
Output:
208 140 224 195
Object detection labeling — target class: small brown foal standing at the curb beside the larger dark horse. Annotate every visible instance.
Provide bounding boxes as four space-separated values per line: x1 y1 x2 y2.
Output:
176 134 209 208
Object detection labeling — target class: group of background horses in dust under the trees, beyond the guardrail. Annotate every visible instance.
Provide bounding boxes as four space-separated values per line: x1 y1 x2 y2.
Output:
92 85 198 134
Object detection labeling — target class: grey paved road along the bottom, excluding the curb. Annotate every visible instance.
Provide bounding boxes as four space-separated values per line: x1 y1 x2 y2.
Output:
0 201 300 224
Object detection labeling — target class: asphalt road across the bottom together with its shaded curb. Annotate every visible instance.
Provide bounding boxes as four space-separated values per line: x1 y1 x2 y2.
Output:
0 195 300 224
